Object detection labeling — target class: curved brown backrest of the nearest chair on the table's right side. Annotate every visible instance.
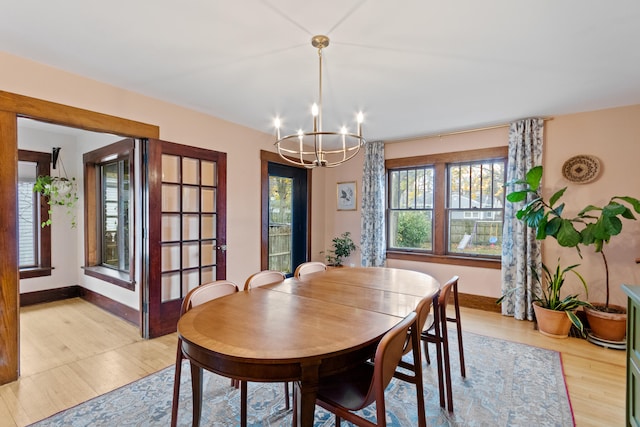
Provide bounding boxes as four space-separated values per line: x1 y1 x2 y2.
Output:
362 312 417 414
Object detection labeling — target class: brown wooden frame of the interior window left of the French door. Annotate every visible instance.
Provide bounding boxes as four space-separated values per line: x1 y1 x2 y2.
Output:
82 138 135 291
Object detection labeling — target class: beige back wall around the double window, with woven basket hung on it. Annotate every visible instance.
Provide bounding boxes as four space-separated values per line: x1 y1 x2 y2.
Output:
326 105 640 305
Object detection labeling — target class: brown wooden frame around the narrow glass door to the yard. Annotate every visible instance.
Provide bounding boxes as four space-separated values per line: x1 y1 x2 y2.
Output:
260 150 313 270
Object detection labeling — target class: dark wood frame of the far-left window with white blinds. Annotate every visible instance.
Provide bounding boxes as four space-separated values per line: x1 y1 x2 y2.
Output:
18 150 53 279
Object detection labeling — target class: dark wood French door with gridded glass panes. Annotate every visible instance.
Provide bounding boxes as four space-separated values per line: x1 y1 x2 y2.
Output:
142 139 227 338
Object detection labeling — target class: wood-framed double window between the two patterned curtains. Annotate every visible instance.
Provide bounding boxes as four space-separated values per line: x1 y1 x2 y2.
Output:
386 147 507 268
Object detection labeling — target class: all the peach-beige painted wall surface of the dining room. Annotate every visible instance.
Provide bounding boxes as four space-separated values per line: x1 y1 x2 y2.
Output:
5 52 640 310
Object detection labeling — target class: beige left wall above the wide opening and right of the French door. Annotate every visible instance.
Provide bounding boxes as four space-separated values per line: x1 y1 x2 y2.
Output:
0 52 308 298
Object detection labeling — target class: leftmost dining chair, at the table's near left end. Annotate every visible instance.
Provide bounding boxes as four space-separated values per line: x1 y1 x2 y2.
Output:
171 280 238 427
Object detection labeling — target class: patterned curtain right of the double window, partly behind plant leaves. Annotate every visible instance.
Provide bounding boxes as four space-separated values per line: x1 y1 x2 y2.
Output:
502 119 544 320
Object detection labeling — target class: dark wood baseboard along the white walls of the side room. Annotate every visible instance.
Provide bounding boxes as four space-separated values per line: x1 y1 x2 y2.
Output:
20 285 140 328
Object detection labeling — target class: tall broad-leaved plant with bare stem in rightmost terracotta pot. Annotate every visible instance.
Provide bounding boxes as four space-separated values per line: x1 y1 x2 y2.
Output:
507 166 640 341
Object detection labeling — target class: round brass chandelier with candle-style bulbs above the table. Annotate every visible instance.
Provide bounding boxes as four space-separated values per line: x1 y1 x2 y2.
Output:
274 35 366 169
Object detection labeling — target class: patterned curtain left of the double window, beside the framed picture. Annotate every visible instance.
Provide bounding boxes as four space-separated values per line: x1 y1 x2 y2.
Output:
360 141 387 267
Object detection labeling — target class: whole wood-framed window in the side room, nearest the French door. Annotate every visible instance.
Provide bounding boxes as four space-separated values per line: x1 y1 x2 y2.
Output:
83 139 135 290
